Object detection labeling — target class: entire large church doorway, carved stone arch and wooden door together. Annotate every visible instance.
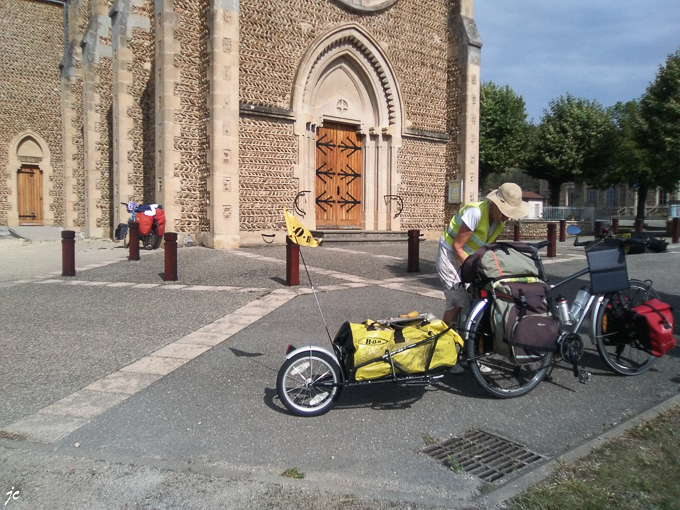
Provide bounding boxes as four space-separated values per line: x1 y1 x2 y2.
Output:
291 23 403 230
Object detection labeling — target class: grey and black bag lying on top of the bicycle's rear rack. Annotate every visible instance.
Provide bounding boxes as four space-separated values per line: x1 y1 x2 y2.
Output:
460 241 545 284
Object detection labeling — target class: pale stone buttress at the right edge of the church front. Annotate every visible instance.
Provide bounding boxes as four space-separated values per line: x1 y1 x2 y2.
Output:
452 0 482 204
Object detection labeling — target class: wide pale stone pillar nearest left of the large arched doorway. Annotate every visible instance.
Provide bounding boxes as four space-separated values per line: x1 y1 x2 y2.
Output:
206 0 240 249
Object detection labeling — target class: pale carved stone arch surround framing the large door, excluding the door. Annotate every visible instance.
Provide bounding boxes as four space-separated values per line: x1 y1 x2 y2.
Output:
291 24 403 230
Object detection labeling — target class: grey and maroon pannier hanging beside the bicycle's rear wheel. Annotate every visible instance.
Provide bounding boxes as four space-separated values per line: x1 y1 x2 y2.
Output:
491 279 560 365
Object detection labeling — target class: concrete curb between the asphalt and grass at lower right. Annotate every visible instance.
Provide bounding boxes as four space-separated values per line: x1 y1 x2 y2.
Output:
473 394 680 508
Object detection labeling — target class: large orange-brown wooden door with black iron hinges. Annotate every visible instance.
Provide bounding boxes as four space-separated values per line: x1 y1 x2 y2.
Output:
315 123 362 228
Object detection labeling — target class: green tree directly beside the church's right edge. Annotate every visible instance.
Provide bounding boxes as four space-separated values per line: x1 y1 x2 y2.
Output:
479 82 529 187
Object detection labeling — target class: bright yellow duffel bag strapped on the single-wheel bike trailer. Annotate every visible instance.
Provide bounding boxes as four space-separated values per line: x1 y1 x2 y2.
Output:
333 318 463 381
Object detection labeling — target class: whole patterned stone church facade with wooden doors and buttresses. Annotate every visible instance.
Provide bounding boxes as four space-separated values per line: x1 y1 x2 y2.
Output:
0 0 481 248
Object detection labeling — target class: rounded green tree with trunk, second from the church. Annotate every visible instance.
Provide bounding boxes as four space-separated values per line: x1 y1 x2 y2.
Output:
526 94 615 205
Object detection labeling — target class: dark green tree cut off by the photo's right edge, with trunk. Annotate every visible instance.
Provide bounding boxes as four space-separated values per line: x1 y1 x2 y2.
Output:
634 50 680 219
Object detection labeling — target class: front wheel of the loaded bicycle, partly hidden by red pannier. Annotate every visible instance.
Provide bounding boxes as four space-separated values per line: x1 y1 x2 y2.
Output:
593 280 659 375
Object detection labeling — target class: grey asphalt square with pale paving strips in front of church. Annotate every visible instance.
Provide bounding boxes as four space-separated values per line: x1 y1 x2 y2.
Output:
0 239 680 508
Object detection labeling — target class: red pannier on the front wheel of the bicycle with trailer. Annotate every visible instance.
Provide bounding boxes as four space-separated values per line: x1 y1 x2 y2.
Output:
631 299 677 357
